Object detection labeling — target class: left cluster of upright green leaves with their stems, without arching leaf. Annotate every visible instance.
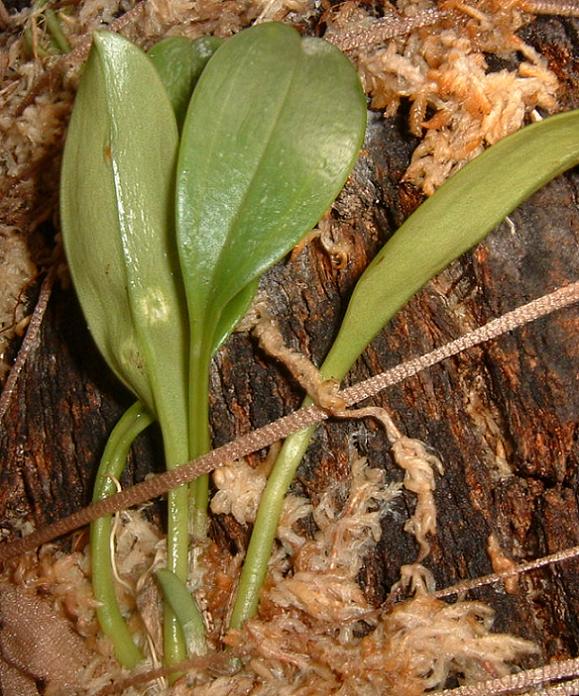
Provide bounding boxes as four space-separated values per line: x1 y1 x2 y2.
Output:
61 24 366 666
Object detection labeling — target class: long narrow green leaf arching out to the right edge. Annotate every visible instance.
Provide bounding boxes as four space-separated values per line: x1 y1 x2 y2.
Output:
322 111 579 379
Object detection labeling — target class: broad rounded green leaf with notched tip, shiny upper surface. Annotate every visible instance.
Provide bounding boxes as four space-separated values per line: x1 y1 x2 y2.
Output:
177 23 366 368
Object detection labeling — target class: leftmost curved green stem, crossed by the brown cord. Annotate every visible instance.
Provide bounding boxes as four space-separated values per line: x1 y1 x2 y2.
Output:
90 401 153 669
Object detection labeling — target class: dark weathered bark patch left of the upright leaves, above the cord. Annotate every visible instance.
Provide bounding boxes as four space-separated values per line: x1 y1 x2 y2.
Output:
0 289 162 529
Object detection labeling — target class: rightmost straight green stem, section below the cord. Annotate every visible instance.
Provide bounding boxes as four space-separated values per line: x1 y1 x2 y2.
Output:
229 426 316 628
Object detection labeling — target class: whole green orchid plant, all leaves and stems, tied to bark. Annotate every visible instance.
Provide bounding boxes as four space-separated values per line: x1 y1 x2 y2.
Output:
61 23 579 667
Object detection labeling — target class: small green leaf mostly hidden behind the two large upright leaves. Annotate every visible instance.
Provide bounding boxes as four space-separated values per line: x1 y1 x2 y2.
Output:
148 36 222 129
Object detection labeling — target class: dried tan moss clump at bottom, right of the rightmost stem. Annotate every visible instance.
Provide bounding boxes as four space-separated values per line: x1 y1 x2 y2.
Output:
191 456 533 696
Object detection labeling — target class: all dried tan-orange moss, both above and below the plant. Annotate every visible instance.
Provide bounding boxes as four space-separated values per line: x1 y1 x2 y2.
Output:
0 0 572 695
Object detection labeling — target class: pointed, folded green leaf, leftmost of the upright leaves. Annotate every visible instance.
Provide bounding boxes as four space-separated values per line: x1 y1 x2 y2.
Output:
61 32 188 436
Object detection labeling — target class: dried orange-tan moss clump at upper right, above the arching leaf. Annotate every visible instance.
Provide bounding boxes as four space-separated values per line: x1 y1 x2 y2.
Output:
328 0 558 194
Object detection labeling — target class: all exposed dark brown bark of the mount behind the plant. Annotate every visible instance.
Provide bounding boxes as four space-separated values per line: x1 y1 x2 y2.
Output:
0 12 579 676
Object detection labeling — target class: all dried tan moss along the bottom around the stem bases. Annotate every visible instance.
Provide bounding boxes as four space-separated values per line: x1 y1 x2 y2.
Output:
4 451 534 696
